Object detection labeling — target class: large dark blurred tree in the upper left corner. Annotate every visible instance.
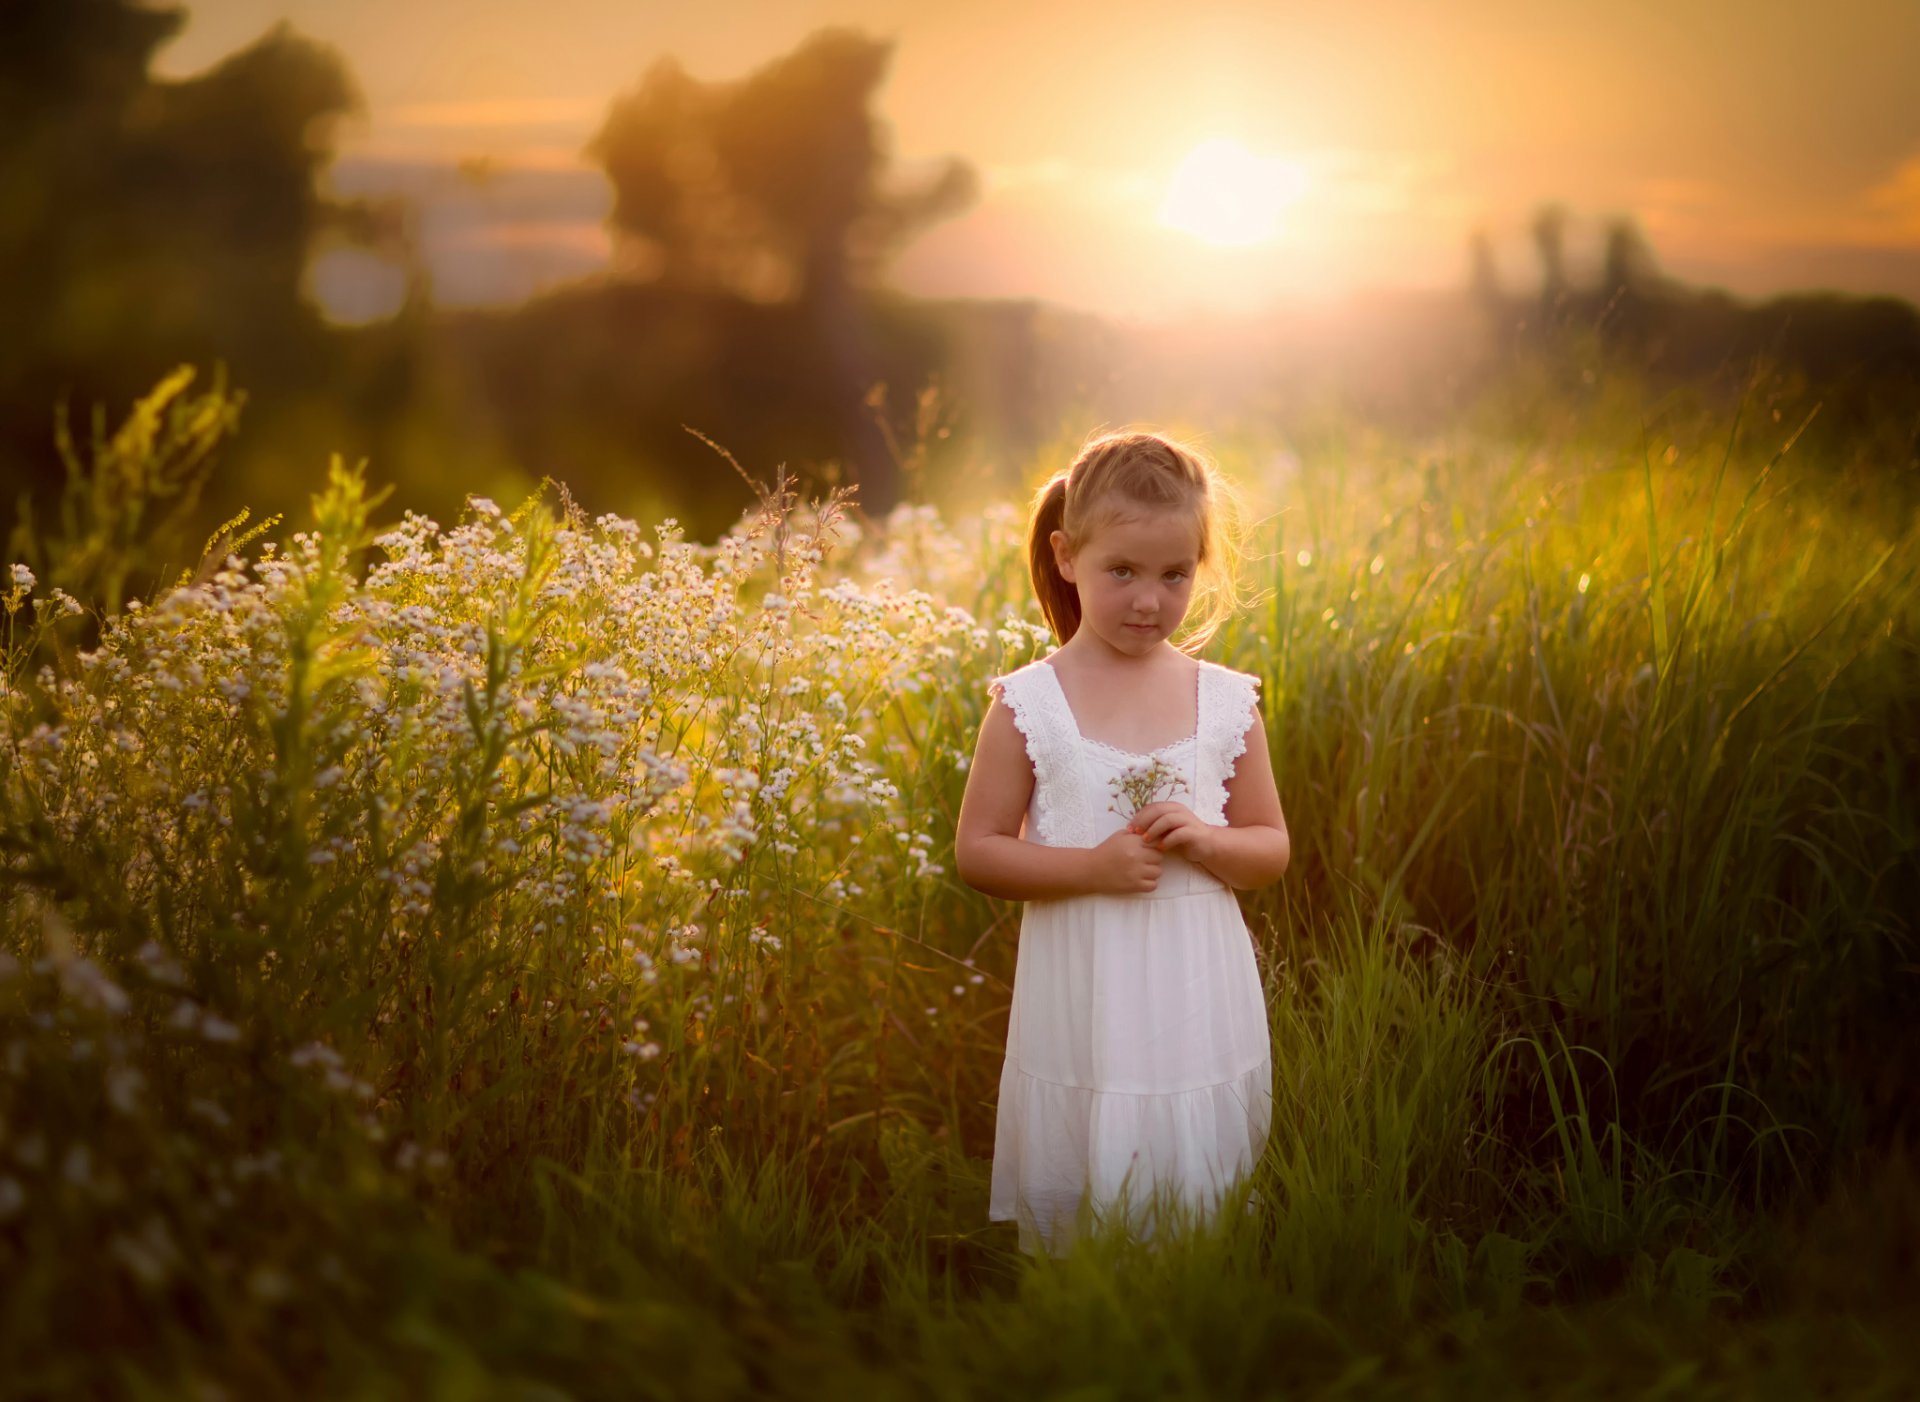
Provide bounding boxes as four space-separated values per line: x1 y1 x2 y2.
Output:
0 0 390 553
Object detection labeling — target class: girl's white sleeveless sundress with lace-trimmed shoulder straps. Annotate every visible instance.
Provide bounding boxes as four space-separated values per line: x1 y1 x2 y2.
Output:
987 661 1273 1254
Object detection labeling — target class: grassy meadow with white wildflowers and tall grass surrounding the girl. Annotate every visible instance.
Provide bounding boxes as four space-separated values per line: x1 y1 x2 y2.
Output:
0 366 1920 1400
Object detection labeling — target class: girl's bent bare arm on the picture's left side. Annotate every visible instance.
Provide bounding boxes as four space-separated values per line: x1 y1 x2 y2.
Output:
954 701 1096 901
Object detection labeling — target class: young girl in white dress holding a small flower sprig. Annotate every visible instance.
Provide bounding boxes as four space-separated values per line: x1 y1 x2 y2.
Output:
954 432 1288 1254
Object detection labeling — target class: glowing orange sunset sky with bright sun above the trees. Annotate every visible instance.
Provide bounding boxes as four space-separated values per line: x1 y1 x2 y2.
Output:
161 0 1920 317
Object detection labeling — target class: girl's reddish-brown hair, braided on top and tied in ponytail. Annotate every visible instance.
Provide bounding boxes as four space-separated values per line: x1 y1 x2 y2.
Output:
1027 428 1244 653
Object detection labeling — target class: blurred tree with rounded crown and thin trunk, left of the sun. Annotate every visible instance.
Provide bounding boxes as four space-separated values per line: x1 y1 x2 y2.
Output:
588 29 977 513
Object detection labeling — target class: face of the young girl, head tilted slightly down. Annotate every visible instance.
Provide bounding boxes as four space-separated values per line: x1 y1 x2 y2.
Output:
1050 509 1200 657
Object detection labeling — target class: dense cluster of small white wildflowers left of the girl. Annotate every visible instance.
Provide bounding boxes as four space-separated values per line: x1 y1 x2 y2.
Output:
0 485 1044 998
